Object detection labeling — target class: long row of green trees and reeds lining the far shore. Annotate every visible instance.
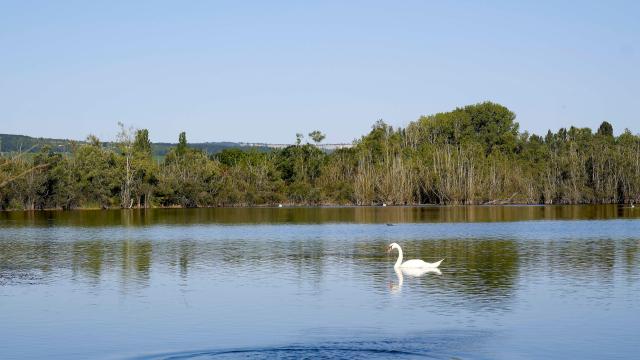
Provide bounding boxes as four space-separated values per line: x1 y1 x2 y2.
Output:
0 102 640 210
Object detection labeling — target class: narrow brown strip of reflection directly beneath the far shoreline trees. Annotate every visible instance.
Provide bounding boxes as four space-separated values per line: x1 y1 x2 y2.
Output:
0 205 640 227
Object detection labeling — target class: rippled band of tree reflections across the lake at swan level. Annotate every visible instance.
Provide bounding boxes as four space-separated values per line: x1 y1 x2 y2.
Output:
0 236 640 298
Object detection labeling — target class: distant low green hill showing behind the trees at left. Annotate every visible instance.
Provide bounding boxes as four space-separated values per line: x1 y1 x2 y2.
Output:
0 134 271 156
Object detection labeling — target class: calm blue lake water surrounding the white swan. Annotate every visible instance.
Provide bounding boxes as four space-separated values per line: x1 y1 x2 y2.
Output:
0 206 640 359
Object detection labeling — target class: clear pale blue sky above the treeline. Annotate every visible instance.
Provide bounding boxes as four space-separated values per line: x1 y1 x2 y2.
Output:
0 0 640 143
